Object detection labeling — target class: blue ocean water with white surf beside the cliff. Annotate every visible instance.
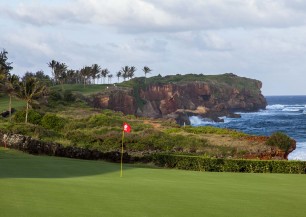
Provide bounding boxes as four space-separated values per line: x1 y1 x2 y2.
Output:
190 96 306 160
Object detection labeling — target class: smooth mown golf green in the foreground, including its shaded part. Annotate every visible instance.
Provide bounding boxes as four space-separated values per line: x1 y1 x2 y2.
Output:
0 148 306 217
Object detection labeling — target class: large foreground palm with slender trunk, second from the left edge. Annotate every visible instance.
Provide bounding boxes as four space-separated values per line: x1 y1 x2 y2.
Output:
15 77 47 123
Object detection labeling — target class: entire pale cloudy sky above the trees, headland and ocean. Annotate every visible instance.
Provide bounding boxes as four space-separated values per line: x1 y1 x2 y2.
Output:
0 0 306 95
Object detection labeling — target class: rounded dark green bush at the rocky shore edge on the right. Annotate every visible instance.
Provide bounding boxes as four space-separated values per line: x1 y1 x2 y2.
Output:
266 132 294 152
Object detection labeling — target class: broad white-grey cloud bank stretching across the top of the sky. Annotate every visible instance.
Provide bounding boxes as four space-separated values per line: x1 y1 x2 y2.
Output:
1 0 306 33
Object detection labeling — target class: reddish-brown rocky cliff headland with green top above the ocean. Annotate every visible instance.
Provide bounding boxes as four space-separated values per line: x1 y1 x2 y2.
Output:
89 73 266 124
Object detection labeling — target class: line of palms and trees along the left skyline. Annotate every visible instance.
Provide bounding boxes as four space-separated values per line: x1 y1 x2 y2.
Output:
0 49 152 123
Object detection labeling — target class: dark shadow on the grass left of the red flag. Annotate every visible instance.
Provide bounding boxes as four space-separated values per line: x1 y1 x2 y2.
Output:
0 148 133 179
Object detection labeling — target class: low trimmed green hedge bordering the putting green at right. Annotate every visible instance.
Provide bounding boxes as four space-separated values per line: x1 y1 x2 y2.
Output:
153 154 306 174
